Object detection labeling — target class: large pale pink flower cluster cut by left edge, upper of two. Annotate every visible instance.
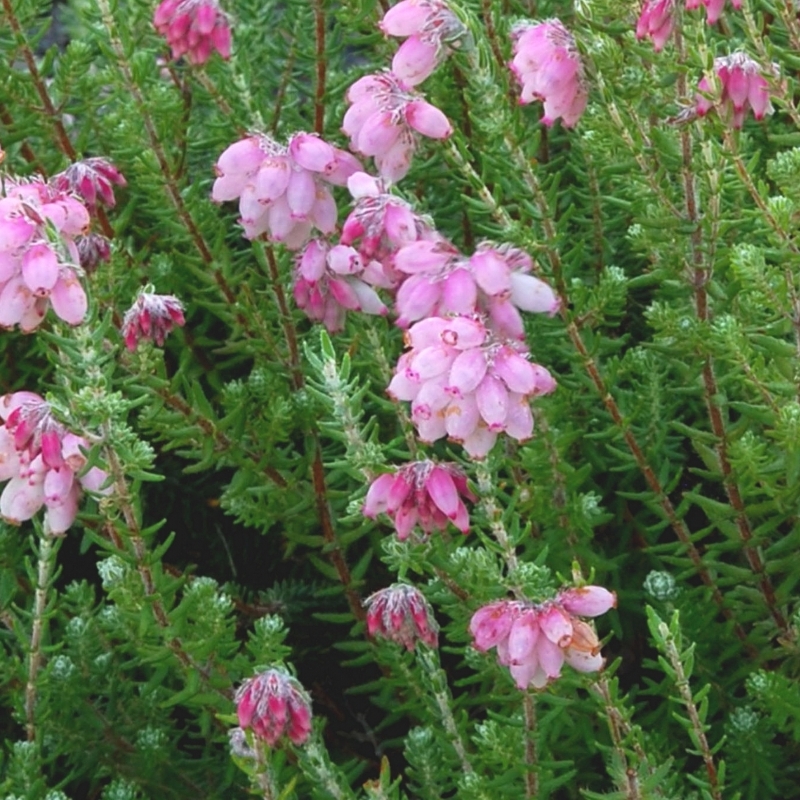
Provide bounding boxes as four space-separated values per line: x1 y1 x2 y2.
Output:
0 179 89 333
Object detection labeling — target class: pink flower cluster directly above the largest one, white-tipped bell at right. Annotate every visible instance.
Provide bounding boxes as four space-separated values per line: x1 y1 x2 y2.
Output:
393 237 560 339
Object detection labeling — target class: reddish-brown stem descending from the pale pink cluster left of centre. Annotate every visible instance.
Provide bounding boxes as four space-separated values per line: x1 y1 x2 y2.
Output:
265 250 367 622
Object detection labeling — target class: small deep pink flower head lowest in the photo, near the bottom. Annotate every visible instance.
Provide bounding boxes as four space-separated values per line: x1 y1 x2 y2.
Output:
234 668 311 747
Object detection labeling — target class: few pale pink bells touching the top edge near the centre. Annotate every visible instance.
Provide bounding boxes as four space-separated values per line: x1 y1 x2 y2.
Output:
380 0 466 86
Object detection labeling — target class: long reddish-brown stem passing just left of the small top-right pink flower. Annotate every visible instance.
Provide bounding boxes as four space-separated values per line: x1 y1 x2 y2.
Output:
675 37 787 634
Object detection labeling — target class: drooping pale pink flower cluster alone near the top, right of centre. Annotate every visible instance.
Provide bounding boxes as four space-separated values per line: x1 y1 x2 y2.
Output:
511 19 588 128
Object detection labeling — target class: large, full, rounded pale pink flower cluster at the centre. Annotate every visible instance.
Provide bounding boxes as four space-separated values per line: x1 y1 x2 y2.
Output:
388 316 556 458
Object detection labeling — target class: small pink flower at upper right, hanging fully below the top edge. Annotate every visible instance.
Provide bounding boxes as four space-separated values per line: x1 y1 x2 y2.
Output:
695 52 778 128
